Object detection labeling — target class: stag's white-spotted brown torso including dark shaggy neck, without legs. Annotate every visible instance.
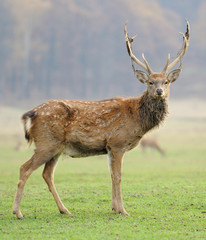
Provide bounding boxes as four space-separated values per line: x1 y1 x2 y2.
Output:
22 92 167 157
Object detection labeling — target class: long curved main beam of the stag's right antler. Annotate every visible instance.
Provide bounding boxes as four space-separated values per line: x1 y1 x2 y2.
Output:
165 18 190 72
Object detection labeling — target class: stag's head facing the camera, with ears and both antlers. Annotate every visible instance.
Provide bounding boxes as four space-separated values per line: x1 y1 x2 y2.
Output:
124 20 190 99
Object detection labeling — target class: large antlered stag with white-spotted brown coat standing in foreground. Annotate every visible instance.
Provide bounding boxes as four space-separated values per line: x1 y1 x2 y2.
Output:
13 20 190 219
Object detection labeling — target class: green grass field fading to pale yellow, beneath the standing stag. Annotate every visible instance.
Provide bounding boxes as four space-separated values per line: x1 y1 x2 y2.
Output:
0 101 206 239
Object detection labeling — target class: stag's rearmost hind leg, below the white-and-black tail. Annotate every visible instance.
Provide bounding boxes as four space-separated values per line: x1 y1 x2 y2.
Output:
13 151 60 219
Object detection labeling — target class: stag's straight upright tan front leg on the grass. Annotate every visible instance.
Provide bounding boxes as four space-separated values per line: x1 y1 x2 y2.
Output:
108 151 129 215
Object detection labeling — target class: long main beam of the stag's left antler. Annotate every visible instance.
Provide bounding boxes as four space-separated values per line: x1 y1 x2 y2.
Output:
124 22 151 74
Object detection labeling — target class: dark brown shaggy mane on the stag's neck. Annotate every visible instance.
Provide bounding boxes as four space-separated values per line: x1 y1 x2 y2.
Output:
139 92 168 133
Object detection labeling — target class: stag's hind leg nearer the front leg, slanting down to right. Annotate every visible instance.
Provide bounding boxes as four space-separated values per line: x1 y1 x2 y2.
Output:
42 154 71 215
